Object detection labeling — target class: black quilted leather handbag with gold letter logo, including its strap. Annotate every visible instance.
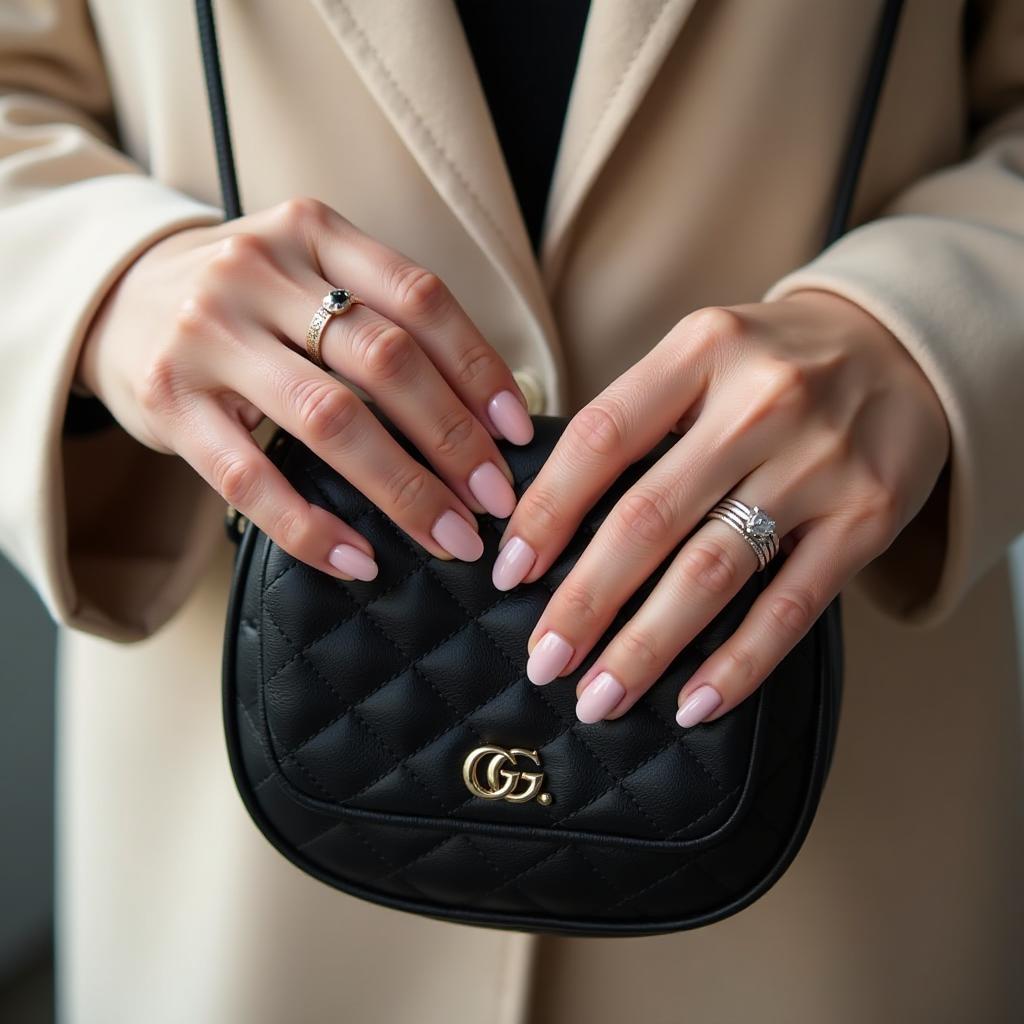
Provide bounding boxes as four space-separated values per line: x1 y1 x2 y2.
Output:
197 0 900 936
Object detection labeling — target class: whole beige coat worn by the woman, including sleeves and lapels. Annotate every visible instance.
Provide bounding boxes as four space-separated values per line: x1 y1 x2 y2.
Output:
0 0 1024 1024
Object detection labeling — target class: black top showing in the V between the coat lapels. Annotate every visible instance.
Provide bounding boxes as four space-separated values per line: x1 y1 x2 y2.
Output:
456 0 590 250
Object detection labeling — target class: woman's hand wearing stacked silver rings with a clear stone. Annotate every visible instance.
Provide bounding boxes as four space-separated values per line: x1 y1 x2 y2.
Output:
494 291 949 727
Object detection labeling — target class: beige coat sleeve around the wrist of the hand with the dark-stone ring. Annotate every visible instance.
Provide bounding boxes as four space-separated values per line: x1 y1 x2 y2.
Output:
0 0 223 640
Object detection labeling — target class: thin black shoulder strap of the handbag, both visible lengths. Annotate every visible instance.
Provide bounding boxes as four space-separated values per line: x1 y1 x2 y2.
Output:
196 0 903 248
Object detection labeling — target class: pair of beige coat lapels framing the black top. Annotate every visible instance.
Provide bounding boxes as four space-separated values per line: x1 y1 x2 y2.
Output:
311 0 694 323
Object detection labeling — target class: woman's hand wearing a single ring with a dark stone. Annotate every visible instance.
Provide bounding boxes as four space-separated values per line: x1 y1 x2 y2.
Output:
77 198 532 580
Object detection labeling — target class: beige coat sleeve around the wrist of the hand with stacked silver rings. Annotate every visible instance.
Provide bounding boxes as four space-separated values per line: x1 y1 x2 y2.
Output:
764 0 1024 627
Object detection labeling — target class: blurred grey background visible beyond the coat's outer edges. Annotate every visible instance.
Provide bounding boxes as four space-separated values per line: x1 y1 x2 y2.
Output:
0 537 1024 1024
